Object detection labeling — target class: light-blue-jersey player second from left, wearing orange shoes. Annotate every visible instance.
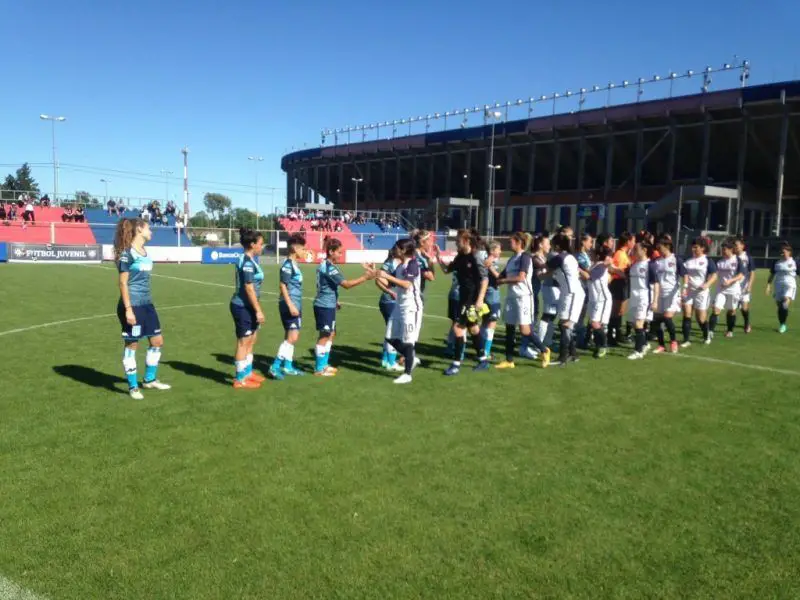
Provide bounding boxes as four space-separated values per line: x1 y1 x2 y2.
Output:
230 228 264 389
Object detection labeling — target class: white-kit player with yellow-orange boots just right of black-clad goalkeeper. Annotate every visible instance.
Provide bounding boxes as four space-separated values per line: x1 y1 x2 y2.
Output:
497 232 550 369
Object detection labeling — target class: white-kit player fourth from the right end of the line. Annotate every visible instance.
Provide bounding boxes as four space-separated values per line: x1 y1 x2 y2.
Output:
681 237 717 348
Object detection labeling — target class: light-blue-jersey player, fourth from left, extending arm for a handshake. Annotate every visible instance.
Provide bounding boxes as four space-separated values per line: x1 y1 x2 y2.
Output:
314 238 375 377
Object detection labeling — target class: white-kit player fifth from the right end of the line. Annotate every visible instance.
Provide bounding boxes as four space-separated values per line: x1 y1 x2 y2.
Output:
652 237 685 354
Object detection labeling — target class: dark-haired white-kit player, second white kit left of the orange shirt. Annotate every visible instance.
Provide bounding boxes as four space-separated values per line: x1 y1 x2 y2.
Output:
547 233 586 367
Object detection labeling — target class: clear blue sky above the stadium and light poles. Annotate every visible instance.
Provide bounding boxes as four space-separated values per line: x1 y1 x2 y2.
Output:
0 0 800 211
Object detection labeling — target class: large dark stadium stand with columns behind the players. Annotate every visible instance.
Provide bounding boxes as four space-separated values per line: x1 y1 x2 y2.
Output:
282 81 800 237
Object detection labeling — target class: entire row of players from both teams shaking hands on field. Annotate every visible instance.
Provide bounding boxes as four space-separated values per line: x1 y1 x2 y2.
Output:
109 219 797 399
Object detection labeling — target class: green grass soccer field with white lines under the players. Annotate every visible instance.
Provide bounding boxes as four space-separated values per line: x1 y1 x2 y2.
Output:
0 265 800 600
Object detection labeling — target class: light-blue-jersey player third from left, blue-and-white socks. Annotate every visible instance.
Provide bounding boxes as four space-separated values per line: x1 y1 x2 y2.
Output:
269 233 306 379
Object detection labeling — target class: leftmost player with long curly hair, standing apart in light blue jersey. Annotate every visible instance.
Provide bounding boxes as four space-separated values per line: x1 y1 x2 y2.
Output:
114 219 170 400
